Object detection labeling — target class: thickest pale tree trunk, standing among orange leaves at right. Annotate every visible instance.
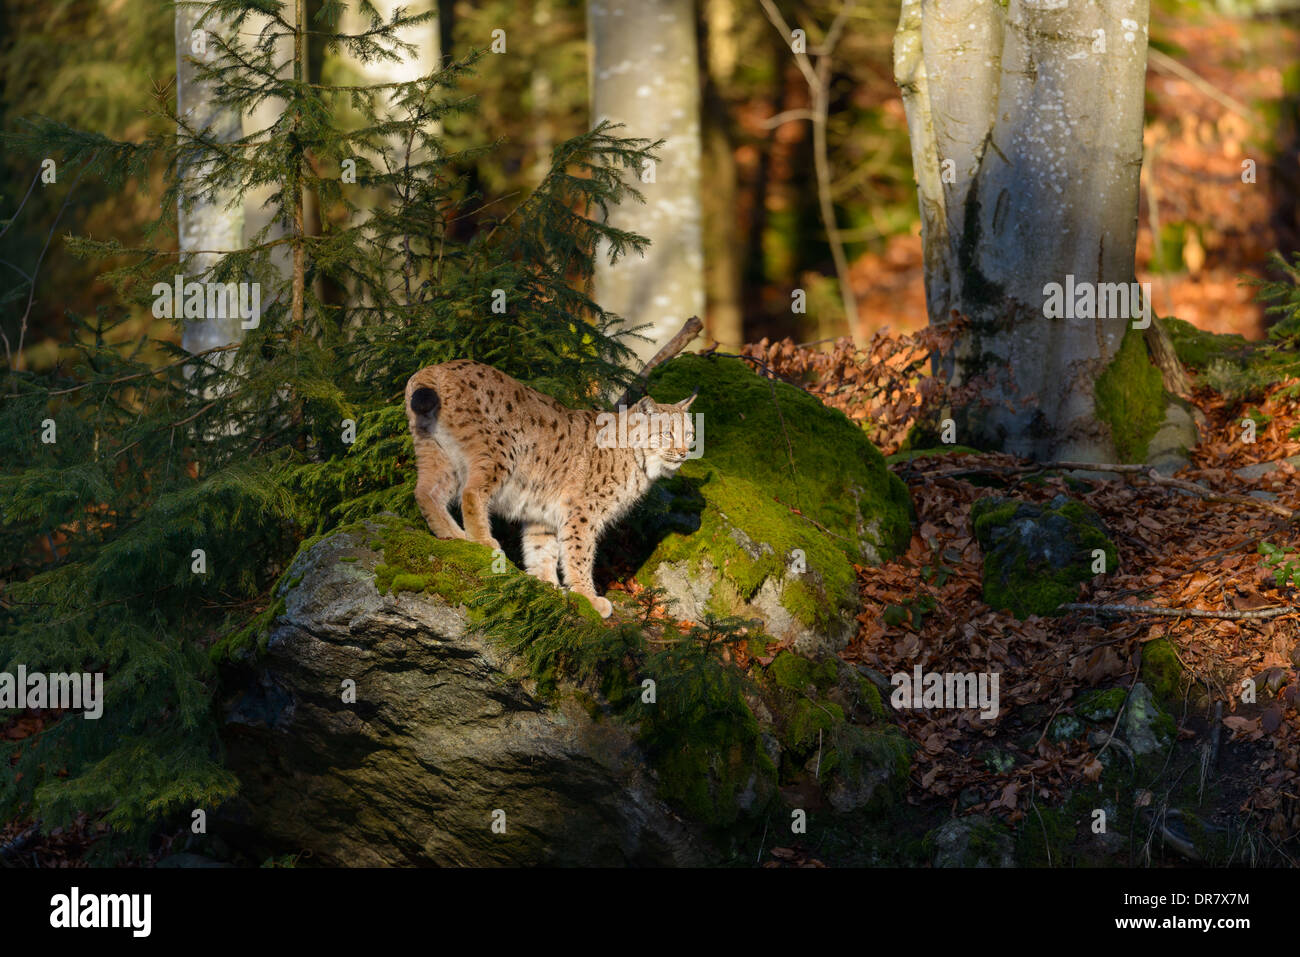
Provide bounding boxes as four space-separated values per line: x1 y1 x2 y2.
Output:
894 0 1164 462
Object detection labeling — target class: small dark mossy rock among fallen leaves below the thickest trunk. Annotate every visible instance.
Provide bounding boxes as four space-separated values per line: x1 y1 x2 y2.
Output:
971 494 1118 619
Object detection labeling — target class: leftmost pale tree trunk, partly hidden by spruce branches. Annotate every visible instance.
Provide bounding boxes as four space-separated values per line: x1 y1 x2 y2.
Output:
176 4 243 352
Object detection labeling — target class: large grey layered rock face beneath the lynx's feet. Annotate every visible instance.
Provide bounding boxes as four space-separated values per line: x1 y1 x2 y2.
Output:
224 524 718 866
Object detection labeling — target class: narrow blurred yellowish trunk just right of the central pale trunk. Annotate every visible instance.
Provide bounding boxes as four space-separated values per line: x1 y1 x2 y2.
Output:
705 0 745 350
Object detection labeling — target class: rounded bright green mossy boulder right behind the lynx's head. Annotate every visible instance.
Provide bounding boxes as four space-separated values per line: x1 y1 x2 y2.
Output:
637 355 911 654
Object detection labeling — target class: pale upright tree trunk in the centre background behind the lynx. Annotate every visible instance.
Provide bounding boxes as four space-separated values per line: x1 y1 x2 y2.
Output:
586 0 705 360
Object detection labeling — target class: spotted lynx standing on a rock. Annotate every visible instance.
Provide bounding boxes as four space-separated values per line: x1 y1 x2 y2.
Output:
406 359 696 618
